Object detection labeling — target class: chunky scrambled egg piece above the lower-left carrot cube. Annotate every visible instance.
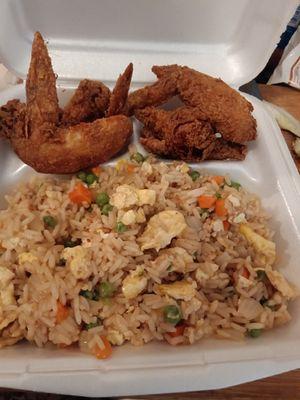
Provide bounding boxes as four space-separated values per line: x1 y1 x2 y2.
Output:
62 246 91 279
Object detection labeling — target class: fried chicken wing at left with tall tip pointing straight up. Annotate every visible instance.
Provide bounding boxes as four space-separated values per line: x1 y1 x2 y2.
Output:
0 32 132 173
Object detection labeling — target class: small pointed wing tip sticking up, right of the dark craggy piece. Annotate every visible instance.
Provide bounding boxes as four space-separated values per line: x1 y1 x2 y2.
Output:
106 63 133 117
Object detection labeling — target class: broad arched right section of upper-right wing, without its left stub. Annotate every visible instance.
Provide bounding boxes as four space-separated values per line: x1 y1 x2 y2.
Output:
152 65 256 144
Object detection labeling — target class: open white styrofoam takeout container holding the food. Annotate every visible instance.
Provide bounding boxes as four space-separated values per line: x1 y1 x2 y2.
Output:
0 0 300 396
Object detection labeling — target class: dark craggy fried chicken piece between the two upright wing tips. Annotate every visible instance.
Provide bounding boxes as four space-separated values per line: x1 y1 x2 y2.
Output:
61 79 110 125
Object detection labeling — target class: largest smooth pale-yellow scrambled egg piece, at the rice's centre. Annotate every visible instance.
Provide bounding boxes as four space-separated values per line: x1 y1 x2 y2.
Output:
140 210 187 251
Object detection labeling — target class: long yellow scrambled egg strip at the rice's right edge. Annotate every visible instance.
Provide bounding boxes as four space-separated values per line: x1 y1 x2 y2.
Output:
240 224 276 264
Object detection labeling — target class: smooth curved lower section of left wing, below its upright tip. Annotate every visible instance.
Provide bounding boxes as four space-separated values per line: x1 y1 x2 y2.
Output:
11 115 132 174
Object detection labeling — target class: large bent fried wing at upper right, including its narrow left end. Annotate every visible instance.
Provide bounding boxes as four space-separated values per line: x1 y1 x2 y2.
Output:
128 65 256 144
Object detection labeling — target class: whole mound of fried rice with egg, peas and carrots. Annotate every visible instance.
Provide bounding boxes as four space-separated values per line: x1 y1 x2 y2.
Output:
0 152 297 358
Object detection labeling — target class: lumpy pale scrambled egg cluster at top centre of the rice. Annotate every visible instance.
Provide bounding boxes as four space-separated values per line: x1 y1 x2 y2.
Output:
110 185 156 210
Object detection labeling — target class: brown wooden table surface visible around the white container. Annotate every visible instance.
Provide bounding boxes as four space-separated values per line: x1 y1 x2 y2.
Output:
0 85 300 400
